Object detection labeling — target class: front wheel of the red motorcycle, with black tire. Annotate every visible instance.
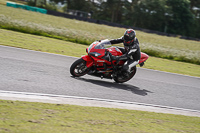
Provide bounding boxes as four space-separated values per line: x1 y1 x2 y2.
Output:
70 58 90 77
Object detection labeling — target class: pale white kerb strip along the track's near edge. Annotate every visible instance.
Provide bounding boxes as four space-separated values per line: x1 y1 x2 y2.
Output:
0 90 200 117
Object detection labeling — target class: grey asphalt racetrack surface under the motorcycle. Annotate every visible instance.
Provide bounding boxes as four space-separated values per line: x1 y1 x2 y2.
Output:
0 46 200 111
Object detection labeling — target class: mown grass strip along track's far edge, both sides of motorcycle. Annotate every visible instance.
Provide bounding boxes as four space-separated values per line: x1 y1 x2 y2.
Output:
0 29 200 77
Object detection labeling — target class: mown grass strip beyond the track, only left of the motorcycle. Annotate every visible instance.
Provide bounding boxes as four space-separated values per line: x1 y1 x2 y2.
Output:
0 29 87 57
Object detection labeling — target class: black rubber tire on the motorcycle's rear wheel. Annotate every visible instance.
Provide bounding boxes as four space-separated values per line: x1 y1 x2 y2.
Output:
114 66 137 83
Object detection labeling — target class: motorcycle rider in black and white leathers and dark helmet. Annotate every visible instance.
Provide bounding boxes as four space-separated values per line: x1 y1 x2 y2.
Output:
110 29 143 73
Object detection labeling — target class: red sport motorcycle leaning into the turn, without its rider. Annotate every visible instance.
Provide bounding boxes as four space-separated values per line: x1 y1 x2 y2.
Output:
70 40 149 83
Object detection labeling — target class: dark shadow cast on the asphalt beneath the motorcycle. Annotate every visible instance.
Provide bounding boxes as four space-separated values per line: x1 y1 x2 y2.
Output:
71 76 153 96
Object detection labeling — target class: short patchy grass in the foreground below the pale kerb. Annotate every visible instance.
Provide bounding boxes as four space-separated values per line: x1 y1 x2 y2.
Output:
0 100 200 133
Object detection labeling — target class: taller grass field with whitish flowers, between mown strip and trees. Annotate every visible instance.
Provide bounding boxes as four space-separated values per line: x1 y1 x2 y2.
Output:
0 5 200 64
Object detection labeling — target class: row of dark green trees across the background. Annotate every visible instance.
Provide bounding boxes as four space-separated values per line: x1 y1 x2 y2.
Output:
30 0 200 38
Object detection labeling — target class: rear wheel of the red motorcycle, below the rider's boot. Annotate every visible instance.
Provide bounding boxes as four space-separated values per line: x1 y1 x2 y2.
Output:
114 66 137 83
